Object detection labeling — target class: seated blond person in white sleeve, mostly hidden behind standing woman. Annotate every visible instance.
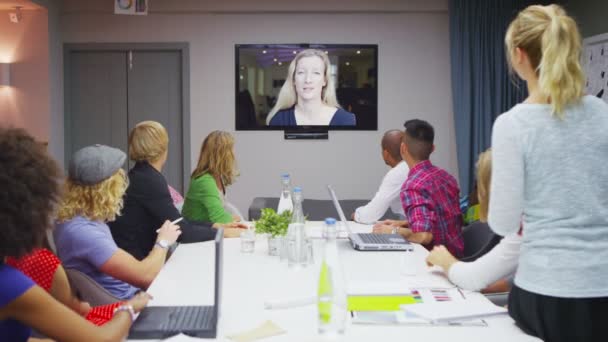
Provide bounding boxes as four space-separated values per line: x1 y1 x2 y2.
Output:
426 149 522 292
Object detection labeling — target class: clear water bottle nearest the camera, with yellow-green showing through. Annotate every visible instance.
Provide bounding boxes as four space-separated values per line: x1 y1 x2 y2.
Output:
317 218 348 336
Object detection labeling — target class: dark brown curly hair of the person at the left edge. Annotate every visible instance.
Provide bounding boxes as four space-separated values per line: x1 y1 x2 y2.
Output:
0 127 63 260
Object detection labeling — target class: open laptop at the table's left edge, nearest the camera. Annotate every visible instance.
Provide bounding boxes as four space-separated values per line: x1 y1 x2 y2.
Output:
129 228 224 340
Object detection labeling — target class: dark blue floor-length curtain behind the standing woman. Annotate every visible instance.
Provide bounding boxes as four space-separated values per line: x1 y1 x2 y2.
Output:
449 0 541 194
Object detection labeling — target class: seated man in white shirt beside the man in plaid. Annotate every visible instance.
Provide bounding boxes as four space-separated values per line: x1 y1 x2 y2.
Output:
352 129 409 224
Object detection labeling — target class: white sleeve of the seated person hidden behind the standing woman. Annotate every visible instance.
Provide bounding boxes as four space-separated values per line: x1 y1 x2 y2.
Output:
448 234 523 291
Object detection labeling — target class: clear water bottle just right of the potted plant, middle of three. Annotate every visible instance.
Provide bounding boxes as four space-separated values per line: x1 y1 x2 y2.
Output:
287 187 309 267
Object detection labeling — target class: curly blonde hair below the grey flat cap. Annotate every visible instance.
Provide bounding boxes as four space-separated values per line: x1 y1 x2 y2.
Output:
57 169 128 222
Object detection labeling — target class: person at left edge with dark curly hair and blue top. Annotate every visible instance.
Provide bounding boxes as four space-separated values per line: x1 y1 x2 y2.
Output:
0 128 149 342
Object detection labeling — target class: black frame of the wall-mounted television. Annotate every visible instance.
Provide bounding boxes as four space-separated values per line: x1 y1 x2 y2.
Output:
234 43 379 134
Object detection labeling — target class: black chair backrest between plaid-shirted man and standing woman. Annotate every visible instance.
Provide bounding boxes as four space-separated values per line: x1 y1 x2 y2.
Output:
461 221 501 261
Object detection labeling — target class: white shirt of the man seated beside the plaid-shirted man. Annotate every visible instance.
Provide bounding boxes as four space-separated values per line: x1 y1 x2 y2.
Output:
355 161 410 224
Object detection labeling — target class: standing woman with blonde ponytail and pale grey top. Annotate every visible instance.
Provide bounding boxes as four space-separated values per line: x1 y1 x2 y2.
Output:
488 5 608 341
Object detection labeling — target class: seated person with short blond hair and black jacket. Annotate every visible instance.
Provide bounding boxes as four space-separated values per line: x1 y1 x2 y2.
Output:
108 121 244 260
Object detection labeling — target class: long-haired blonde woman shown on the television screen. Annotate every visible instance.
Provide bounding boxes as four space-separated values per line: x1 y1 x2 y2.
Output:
266 49 356 126
